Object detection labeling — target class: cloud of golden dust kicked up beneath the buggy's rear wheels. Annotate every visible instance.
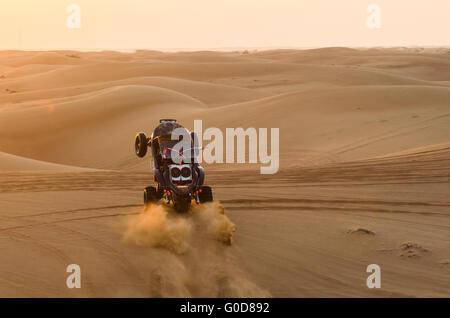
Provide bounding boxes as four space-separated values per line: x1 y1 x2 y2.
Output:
122 202 270 297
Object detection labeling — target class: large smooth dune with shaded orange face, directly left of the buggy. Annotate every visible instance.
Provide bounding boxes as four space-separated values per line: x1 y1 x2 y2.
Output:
0 85 206 168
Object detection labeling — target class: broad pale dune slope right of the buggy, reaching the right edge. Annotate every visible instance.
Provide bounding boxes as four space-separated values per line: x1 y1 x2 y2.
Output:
183 86 450 164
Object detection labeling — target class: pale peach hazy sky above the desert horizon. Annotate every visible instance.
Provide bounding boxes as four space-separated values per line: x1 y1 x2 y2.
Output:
0 0 450 49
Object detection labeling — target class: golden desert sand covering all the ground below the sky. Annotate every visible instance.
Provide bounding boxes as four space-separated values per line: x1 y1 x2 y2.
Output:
0 48 450 297
